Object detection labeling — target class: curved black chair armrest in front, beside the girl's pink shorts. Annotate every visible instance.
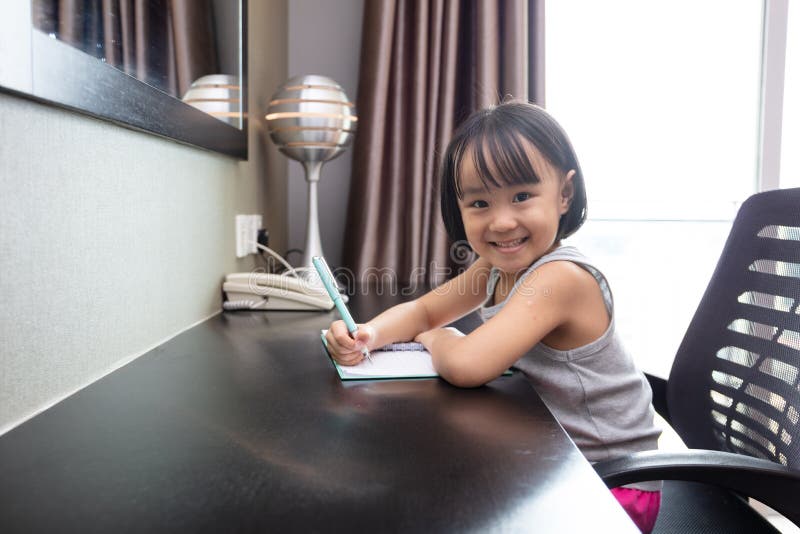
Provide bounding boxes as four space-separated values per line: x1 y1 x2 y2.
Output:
594 449 800 526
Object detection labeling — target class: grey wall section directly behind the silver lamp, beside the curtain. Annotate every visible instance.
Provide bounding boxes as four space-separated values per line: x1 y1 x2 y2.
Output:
288 0 364 266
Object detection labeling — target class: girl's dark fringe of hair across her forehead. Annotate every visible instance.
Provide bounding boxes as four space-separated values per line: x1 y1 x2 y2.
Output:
454 128 541 198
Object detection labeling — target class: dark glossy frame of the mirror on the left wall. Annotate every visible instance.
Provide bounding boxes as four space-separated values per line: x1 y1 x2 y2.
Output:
0 0 247 159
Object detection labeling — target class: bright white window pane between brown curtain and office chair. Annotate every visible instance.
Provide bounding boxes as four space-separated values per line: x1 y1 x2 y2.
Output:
545 0 763 376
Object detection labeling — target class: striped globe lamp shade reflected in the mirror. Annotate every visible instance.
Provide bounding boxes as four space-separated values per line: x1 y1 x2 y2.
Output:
182 74 242 128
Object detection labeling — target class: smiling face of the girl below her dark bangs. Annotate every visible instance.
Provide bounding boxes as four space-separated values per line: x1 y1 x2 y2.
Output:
459 146 575 276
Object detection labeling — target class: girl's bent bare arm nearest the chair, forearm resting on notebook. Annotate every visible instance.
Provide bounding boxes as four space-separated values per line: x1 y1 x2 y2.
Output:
416 261 609 387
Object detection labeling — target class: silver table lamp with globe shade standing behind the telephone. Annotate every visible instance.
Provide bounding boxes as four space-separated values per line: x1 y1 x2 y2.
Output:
266 75 358 278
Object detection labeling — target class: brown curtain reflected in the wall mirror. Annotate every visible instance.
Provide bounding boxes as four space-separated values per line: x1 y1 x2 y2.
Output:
33 0 219 98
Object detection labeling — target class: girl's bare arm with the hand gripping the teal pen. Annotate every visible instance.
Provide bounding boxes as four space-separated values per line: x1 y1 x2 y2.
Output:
326 259 491 365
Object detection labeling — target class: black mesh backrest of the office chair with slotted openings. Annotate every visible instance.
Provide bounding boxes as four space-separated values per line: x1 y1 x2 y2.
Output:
667 189 800 469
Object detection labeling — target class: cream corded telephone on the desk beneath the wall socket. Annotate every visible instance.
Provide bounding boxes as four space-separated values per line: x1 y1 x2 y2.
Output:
222 273 347 310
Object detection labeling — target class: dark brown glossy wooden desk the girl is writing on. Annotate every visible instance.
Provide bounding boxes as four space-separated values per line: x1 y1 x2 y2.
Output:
0 297 638 534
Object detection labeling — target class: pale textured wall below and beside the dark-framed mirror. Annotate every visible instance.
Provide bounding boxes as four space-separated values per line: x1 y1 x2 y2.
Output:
0 0 287 433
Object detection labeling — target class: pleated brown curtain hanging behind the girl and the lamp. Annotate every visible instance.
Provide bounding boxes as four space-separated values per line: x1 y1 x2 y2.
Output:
343 0 543 285
